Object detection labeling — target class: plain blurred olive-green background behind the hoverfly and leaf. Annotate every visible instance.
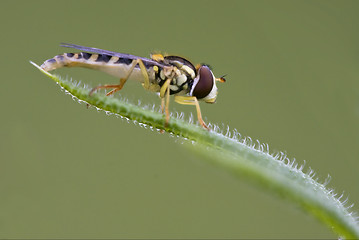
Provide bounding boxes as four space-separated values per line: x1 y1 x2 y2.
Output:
0 1 359 238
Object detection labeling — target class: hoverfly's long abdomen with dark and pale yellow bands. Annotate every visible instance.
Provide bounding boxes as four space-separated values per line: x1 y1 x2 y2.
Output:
41 52 155 82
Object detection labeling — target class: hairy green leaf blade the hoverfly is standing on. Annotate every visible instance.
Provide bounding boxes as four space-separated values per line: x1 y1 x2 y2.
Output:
31 62 359 239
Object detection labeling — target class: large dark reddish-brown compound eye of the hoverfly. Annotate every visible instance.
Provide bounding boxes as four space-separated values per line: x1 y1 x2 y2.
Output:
192 66 214 99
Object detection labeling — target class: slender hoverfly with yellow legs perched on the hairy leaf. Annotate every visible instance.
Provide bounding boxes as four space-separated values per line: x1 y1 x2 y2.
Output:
41 43 225 129
